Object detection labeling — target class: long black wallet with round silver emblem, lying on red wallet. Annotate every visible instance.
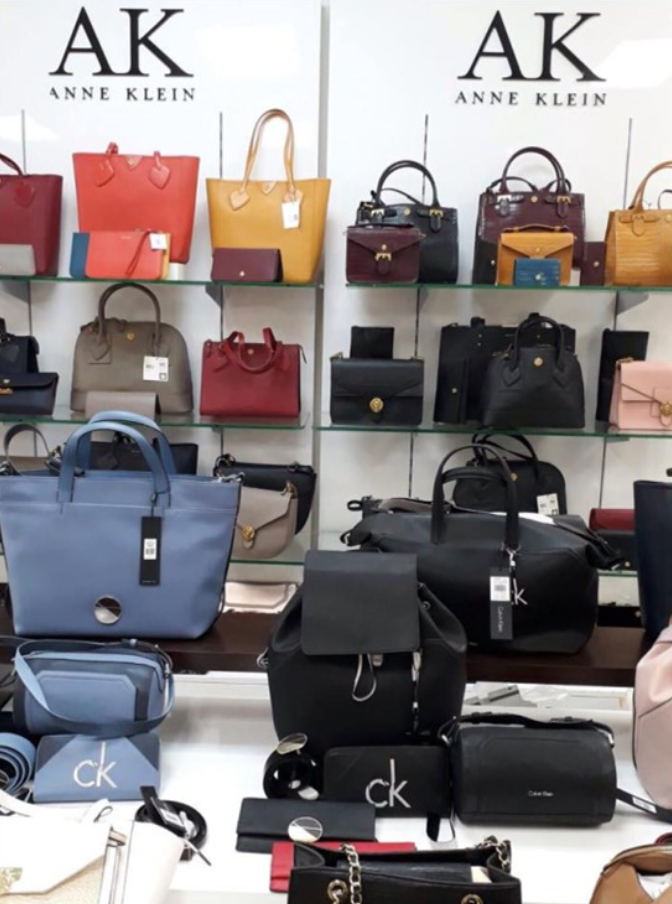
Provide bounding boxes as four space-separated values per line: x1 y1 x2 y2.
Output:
236 797 376 854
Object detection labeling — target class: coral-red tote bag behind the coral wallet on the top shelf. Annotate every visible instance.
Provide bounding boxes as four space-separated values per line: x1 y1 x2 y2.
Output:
72 142 200 264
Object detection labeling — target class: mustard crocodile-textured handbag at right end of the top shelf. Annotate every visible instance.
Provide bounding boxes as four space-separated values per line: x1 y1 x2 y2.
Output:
605 160 672 286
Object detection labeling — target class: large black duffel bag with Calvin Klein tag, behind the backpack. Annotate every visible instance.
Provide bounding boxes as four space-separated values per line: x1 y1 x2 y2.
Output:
345 445 616 653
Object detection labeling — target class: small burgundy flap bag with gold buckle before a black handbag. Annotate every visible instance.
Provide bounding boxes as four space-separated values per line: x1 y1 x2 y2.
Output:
345 226 422 283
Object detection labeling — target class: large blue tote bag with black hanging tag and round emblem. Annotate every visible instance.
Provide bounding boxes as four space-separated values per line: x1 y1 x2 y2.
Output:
0 421 240 639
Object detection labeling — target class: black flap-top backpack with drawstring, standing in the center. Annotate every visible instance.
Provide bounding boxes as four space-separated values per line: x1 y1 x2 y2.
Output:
267 552 466 756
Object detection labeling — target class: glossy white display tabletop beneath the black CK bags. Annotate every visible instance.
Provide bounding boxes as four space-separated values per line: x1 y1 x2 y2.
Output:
161 675 652 904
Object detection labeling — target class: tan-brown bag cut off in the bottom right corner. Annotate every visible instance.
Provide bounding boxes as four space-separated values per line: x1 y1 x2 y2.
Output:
590 836 672 904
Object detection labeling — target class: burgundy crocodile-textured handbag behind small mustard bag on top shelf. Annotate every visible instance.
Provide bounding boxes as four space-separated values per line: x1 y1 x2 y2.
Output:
473 147 585 285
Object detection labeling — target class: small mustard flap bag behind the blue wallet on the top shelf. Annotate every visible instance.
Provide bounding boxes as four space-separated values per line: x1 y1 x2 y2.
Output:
496 224 574 286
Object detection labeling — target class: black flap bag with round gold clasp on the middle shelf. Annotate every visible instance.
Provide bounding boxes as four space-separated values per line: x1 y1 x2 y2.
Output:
329 356 425 427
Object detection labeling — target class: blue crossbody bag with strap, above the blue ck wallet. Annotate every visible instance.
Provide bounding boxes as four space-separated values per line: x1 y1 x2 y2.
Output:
13 640 175 738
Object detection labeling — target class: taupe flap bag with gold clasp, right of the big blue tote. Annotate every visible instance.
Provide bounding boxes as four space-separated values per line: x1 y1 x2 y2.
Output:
233 483 299 559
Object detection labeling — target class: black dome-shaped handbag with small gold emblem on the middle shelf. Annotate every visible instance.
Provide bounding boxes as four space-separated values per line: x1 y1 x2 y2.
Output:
481 317 585 429
